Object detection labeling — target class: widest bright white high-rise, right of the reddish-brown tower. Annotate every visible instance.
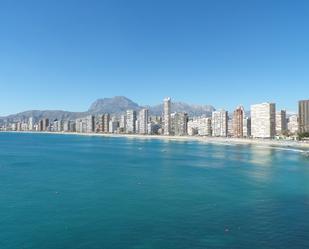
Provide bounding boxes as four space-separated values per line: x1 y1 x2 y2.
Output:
251 103 276 138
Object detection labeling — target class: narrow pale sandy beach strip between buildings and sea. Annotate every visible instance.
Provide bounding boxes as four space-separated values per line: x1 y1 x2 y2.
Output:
1 131 309 152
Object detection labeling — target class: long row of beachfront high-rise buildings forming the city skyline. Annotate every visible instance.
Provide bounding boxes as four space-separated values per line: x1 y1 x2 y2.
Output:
0 97 309 140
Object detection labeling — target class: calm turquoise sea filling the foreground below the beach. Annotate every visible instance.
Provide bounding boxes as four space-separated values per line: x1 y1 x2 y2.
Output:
0 133 309 249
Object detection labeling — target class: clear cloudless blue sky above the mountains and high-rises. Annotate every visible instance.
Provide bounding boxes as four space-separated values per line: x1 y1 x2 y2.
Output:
0 0 309 116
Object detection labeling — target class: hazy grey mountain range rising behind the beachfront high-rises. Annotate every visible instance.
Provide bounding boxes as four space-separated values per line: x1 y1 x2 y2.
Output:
0 96 215 122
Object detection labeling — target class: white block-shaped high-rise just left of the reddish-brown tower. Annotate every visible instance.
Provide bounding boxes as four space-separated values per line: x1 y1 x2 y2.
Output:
211 110 228 137
